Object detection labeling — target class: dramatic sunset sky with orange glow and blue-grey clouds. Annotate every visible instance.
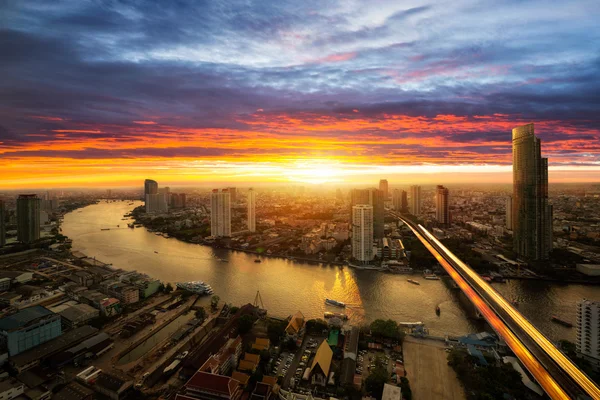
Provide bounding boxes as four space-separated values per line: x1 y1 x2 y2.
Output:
0 0 600 188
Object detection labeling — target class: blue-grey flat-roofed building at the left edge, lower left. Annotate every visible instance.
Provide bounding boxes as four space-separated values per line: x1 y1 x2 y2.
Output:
0 306 62 357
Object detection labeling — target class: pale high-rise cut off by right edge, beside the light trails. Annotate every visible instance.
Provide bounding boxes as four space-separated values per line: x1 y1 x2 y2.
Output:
575 299 600 370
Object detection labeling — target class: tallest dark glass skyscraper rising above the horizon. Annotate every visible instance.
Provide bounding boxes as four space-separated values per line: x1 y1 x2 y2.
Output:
512 124 552 261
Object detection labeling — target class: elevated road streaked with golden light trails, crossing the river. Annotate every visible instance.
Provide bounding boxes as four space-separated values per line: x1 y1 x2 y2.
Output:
395 214 600 399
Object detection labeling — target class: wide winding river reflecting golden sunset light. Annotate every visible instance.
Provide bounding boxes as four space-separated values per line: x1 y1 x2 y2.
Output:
62 202 600 340
